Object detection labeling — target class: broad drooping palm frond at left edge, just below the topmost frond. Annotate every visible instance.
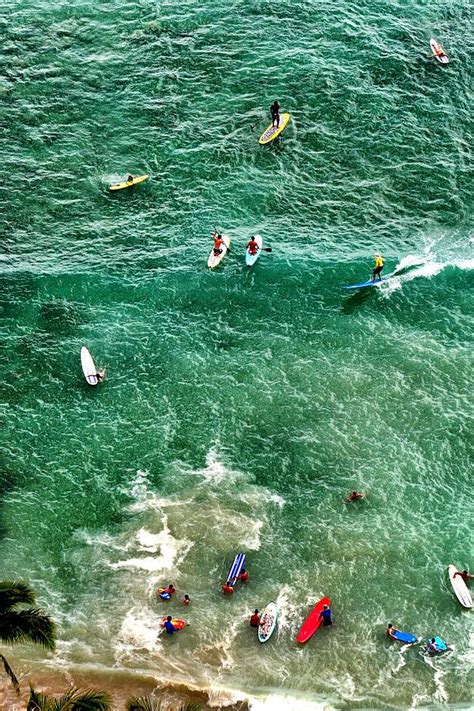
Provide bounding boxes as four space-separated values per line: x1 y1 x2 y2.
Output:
0 608 56 650
